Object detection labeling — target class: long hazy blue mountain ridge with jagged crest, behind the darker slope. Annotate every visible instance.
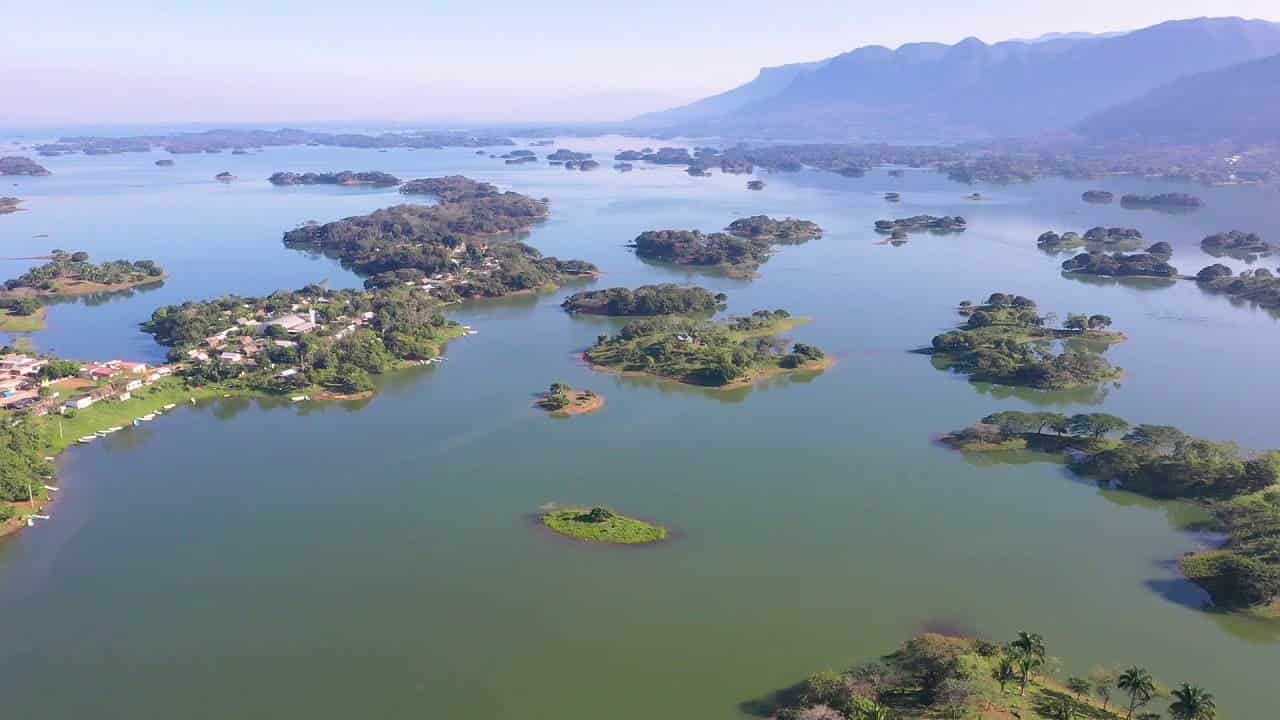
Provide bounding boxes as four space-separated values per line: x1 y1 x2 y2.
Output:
636 18 1280 141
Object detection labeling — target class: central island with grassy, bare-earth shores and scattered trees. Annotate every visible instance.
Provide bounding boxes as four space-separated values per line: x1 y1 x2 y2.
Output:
584 310 831 388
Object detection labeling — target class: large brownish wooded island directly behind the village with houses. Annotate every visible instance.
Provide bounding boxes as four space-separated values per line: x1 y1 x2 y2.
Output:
284 176 598 301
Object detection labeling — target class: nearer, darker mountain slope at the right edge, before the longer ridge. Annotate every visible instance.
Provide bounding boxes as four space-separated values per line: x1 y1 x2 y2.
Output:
1079 50 1280 145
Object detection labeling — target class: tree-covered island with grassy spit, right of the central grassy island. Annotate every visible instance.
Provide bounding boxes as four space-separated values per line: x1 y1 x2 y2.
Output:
919 292 1124 389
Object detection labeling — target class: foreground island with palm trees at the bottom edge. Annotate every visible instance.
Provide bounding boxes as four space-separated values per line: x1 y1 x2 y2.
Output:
762 632 1217 720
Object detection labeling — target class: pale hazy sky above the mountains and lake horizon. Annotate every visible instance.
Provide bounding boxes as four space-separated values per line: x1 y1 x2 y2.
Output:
0 0 1280 126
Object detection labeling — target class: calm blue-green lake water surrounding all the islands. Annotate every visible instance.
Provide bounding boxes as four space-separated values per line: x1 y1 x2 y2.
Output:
0 138 1280 720
